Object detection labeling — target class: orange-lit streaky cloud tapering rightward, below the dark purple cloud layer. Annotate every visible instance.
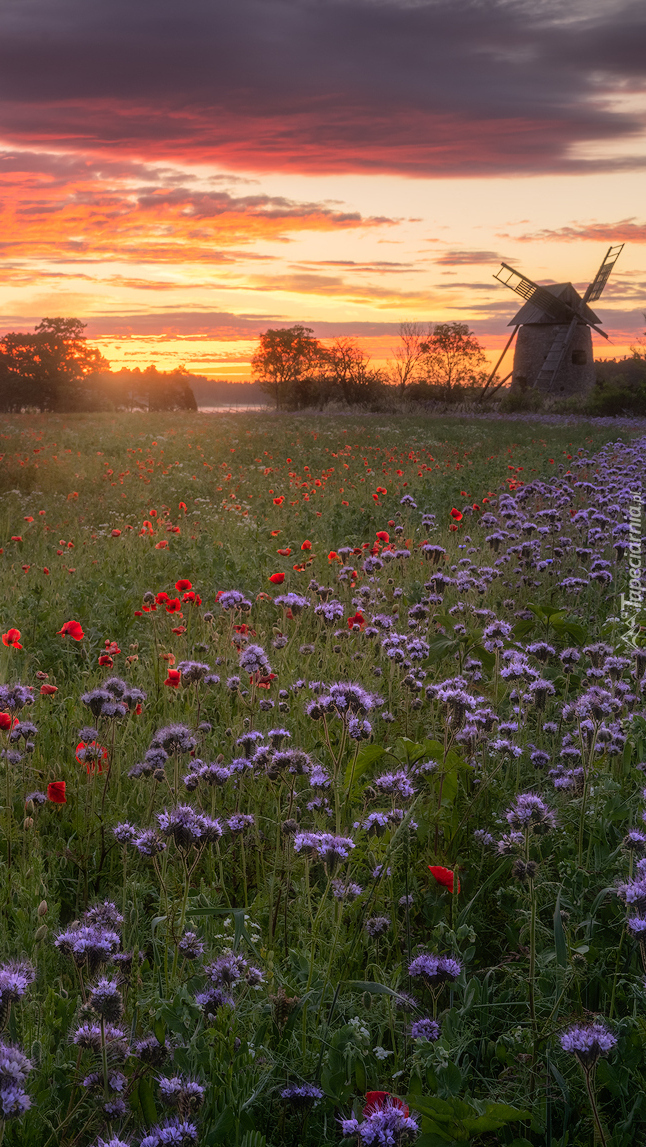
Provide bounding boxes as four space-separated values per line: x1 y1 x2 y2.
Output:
0 151 394 265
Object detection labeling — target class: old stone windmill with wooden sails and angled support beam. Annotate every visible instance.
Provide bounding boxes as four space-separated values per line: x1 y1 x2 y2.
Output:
481 243 624 397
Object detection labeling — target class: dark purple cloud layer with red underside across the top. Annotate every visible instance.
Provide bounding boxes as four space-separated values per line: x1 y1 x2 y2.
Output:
0 0 646 175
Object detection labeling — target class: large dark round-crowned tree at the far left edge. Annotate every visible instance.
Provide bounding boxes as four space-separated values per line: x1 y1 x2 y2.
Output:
0 319 109 411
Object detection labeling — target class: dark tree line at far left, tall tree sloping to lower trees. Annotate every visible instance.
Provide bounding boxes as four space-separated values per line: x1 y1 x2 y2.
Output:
0 319 197 413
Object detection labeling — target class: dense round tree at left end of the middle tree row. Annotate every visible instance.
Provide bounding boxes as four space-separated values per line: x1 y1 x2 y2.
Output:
251 323 325 409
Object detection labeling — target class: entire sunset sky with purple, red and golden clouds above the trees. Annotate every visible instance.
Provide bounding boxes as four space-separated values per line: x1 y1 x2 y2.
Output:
0 0 646 380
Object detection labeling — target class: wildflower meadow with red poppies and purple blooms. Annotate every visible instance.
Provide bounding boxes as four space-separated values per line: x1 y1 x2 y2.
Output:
0 414 646 1147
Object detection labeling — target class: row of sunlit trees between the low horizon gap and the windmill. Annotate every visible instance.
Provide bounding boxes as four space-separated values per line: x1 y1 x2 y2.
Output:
251 322 487 409
